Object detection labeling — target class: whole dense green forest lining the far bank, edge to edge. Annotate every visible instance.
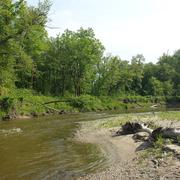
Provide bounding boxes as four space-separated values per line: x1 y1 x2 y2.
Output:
0 0 180 116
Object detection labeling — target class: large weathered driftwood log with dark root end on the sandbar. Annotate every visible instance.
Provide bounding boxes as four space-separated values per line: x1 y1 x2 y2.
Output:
116 122 180 141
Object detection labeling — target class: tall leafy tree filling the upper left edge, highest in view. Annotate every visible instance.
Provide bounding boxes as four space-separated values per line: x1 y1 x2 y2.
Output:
0 0 50 88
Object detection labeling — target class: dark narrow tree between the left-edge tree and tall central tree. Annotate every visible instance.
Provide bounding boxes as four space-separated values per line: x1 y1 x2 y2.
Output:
36 36 71 96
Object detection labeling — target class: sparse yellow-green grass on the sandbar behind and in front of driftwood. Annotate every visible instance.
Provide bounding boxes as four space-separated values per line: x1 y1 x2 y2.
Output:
98 111 180 159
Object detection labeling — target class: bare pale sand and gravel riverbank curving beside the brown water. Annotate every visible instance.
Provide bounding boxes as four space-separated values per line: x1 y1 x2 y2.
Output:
76 117 180 180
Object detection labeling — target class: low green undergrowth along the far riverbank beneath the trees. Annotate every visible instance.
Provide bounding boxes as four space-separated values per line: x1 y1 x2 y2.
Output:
0 89 160 119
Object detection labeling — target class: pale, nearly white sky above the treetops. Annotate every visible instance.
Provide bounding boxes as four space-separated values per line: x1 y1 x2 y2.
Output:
27 0 180 63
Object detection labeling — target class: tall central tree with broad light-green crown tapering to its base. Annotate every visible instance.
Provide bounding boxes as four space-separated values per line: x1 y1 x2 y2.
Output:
58 28 104 96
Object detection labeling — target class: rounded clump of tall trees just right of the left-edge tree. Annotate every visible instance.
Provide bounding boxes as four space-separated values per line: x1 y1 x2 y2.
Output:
36 28 104 96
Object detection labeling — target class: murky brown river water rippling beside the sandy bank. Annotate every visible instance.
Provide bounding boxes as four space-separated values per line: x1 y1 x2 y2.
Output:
0 113 115 180
